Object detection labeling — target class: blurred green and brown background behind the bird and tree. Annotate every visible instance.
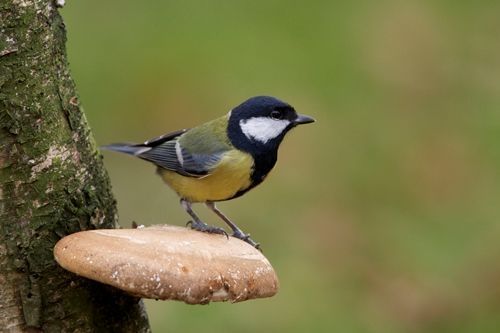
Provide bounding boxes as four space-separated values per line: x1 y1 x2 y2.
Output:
62 0 500 333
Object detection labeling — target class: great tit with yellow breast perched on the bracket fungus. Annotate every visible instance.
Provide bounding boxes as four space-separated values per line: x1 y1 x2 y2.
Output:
102 96 314 248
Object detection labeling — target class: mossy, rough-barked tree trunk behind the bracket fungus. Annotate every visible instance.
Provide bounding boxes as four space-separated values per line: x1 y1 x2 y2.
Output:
0 0 149 332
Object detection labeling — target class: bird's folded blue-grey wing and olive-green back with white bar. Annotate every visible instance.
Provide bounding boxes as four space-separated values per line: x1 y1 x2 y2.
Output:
138 120 231 178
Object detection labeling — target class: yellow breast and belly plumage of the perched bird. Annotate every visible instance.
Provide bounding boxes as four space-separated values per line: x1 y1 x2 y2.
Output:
158 150 253 202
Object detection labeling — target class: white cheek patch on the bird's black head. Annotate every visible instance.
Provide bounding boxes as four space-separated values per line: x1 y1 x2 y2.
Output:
240 117 290 144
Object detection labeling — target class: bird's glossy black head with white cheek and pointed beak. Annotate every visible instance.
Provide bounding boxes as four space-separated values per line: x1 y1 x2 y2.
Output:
228 96 314 155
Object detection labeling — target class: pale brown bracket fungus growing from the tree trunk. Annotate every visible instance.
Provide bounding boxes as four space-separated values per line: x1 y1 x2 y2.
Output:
54 225 278 304
